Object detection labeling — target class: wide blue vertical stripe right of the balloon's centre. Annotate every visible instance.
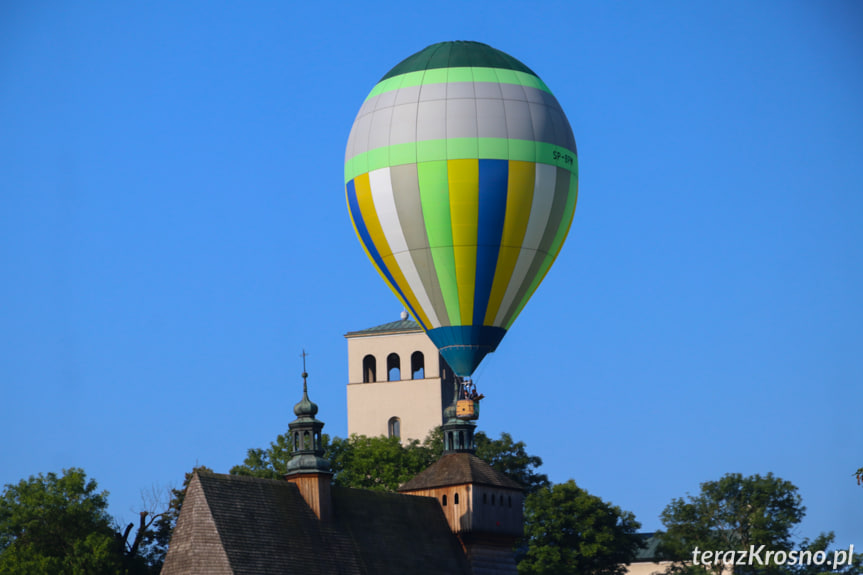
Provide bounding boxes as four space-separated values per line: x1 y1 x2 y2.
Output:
473 160 509 325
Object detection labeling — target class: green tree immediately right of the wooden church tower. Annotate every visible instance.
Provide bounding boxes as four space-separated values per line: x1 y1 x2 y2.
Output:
518 479 641 575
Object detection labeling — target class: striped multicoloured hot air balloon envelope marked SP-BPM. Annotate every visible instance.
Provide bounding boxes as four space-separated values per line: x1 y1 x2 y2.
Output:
345 42 578 377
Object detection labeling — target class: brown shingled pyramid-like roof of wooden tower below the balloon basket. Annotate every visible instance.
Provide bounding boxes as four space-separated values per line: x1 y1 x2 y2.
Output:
399 453 524 492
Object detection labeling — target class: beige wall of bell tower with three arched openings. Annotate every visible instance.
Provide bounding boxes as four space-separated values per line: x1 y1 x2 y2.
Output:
347 331 451 442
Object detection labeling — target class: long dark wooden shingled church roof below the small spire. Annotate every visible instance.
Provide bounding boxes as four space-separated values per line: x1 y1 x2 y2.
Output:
162 473 470 575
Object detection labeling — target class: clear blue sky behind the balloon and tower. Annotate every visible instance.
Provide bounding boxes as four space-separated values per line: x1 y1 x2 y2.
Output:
0 1 863 548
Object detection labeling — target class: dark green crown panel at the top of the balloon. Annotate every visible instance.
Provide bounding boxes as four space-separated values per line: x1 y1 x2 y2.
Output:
381 41 536 81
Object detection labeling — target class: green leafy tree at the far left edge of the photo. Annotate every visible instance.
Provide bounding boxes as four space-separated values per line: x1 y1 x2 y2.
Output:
0 468 126 575
